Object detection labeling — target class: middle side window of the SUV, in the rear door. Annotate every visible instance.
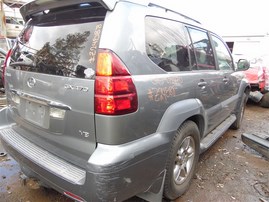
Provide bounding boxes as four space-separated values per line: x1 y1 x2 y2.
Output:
186 28 216 70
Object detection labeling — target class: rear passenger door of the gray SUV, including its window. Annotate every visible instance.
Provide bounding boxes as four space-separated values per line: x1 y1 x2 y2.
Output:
188 27 222 132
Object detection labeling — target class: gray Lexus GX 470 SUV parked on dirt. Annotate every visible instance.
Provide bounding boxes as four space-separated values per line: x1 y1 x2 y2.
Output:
0 0 250 201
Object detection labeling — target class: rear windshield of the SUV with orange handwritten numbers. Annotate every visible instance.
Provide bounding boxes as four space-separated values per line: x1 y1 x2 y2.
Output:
10 3 106 78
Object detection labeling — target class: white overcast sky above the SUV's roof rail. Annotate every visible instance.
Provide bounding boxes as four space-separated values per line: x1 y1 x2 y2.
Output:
165 0 269 36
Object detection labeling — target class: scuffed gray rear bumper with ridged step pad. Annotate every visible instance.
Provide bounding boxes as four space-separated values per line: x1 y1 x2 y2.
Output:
0 108 171 201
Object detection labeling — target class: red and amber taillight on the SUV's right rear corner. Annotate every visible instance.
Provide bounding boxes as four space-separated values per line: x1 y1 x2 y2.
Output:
95 49 138 115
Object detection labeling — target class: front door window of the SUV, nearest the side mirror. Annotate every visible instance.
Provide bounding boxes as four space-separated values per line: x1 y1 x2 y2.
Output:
212 36 233 70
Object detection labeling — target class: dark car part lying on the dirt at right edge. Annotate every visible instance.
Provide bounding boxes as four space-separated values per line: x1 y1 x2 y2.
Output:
241 133 269 160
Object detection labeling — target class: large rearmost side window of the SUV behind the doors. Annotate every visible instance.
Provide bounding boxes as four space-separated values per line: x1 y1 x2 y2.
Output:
146 17 191 72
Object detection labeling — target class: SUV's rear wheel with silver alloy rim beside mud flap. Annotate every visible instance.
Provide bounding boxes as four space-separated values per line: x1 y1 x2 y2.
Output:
164 121 200 200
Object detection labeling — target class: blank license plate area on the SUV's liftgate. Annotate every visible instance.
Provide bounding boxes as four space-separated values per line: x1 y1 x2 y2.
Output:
25 100 49 128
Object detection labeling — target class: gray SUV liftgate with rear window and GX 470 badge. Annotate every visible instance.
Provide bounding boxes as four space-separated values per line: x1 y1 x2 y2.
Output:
5 1 106 162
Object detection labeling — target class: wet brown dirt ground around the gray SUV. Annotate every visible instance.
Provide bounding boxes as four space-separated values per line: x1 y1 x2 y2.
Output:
0 100 269 202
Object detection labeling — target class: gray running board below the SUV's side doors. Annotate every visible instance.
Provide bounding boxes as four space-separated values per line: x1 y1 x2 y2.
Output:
200 114 236 153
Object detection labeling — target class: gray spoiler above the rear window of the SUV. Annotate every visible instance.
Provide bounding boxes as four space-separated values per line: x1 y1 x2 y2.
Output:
20 0 118 22
